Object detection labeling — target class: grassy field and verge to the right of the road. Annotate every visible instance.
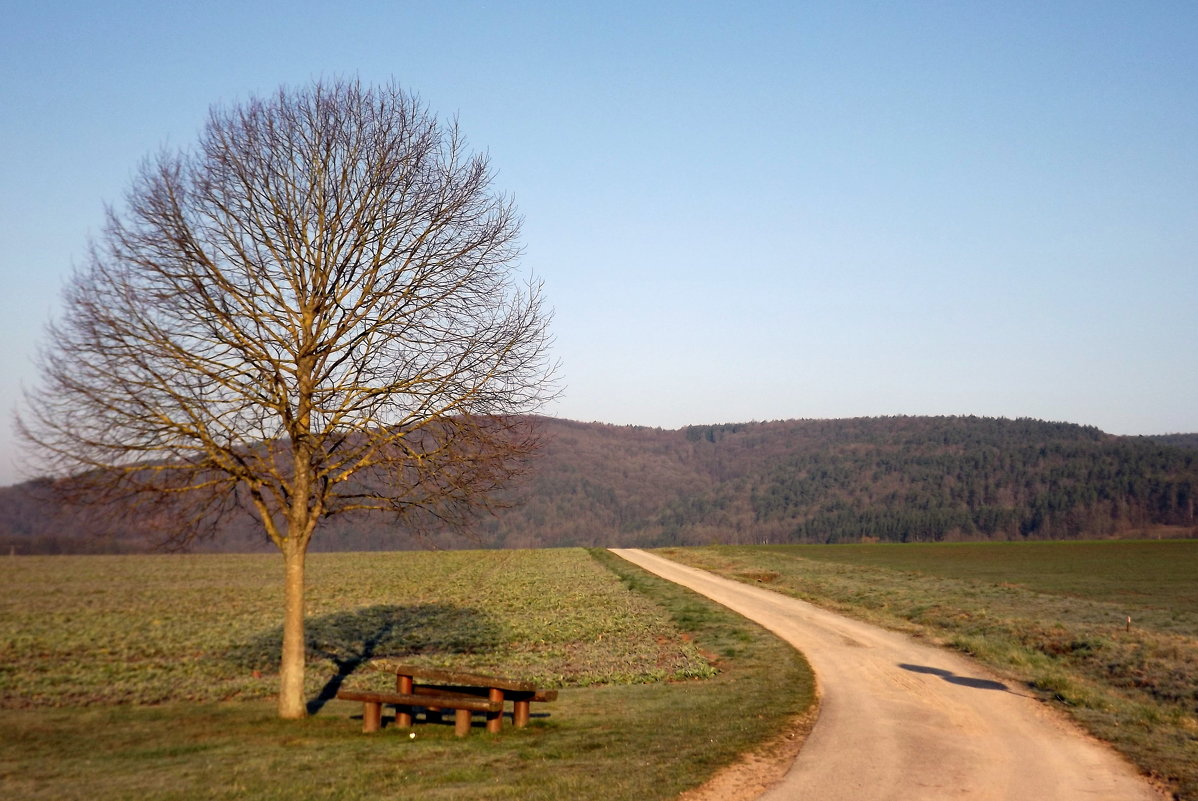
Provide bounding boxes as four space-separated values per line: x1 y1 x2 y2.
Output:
662 540 1198 801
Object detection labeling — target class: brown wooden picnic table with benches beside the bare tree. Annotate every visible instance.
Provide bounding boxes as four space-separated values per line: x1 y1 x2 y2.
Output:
337 665 557 736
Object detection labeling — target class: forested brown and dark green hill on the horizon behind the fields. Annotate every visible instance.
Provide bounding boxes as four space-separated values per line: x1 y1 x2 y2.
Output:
0 417 1198 551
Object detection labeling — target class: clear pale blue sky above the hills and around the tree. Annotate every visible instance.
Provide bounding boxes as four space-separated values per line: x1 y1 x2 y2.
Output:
0 0 1198 483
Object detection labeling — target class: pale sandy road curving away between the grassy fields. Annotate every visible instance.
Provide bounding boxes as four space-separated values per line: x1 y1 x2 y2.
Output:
615 550 1164 801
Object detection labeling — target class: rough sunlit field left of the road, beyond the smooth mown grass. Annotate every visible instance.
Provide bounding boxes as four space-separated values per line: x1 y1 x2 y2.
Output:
0 550 708 706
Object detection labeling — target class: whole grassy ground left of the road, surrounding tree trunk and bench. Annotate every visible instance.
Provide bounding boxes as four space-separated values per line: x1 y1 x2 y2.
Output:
0 550 812 801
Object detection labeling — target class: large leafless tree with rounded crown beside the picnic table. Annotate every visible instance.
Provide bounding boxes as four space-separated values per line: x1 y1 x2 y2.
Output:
18 81 552 717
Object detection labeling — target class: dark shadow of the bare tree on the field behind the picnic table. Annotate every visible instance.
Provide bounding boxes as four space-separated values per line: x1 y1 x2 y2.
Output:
225 603 503 715
